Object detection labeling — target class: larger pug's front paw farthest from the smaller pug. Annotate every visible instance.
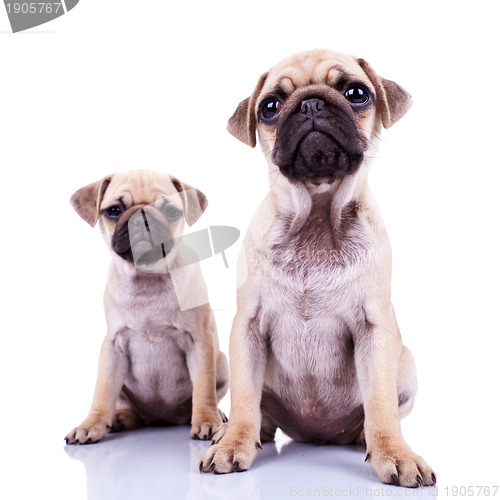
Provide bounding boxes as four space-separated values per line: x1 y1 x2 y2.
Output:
367 444 436 488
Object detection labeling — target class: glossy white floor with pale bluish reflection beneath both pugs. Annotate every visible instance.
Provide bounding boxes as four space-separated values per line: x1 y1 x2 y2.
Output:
65 427 437 500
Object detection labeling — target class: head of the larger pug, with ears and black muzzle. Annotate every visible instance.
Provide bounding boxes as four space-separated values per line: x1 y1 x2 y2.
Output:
228 49 411 185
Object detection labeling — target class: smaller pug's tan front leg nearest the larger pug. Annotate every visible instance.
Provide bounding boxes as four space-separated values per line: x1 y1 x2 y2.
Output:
187 307 222 439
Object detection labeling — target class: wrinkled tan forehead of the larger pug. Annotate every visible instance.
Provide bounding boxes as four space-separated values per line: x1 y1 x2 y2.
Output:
262 49 371 94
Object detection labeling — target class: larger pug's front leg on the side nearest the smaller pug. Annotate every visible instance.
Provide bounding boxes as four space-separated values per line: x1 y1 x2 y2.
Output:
200 307 267 474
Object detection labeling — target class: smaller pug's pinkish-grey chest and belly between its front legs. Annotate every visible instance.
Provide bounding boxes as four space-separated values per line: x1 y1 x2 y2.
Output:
113 287 194 422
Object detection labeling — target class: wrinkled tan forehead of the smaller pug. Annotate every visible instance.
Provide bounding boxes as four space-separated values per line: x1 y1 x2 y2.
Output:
102 170 182 207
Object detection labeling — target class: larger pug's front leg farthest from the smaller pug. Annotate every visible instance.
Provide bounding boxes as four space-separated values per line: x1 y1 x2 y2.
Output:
355 306 436 488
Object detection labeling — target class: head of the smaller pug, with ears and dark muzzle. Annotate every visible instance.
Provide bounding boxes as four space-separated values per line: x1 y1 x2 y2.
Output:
71 170 208 272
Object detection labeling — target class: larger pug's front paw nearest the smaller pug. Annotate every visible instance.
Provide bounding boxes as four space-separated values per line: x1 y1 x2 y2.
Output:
200 433 262 474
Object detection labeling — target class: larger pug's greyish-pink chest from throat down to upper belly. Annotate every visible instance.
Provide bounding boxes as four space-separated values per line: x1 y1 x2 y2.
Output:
261 197 369 378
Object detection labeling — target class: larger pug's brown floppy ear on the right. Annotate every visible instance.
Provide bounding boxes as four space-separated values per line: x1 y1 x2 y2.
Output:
358 59 413 128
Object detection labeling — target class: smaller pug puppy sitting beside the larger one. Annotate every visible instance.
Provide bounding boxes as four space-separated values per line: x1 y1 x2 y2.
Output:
66 170 229 444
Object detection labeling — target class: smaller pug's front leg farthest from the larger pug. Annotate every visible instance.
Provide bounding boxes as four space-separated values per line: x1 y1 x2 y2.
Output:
66 334 129 444
